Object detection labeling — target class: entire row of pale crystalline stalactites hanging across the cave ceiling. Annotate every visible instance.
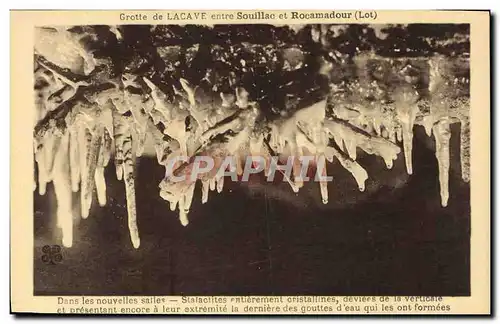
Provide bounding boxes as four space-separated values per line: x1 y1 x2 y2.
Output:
35 52 469 248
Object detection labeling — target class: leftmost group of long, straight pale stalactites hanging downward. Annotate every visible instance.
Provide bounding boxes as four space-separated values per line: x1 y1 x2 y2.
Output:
34 97 141 248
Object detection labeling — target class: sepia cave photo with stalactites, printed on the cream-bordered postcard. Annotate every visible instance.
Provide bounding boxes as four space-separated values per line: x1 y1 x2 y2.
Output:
12 12 489 314
